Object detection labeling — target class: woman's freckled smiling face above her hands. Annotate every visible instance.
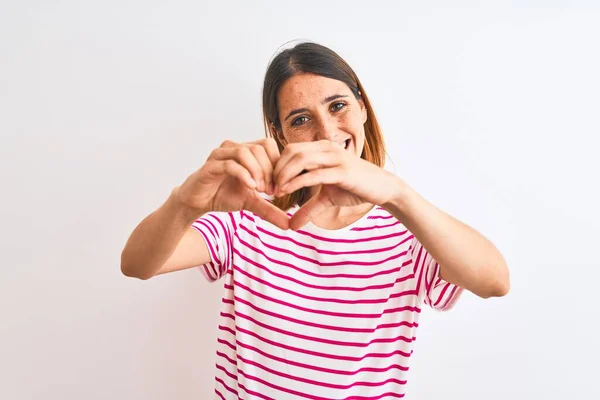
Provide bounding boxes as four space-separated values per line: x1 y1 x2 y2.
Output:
276 74 367 157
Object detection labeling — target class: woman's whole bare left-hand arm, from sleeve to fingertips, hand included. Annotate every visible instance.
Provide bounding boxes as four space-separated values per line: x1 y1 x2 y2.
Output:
121 139 289 279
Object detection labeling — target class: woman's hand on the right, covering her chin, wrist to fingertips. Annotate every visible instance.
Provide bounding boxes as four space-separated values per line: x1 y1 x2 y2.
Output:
273 140 399 230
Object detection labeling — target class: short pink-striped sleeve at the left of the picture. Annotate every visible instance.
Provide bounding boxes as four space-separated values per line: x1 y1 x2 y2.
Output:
192 212 237 282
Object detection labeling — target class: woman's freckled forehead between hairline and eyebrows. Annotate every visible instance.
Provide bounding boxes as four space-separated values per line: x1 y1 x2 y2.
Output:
277 74 352 110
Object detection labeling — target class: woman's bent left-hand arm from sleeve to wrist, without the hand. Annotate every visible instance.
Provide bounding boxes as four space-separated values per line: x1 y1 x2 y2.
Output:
121 188 210 279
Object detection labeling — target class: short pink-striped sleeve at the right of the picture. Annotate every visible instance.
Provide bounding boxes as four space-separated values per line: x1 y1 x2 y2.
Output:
411 238 463 311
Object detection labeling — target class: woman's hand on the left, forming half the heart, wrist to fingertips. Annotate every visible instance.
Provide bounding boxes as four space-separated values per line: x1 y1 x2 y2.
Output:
177 138 289 229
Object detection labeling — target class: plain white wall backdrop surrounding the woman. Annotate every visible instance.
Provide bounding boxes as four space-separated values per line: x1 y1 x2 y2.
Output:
0 0 600 400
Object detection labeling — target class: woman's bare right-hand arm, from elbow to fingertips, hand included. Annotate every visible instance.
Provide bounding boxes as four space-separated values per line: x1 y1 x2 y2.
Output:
275 140 509 298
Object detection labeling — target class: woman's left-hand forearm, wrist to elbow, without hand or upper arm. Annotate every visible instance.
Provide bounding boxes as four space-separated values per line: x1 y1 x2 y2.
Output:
121 188 205 279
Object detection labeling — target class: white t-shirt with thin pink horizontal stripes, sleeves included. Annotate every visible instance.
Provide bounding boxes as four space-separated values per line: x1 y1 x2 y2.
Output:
193 206 462 400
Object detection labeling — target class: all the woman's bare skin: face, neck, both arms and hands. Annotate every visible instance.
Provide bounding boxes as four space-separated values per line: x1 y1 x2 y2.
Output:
121 74 510 298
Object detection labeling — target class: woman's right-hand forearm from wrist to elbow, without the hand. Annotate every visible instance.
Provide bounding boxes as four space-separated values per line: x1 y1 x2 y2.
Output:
383 179 510 298
